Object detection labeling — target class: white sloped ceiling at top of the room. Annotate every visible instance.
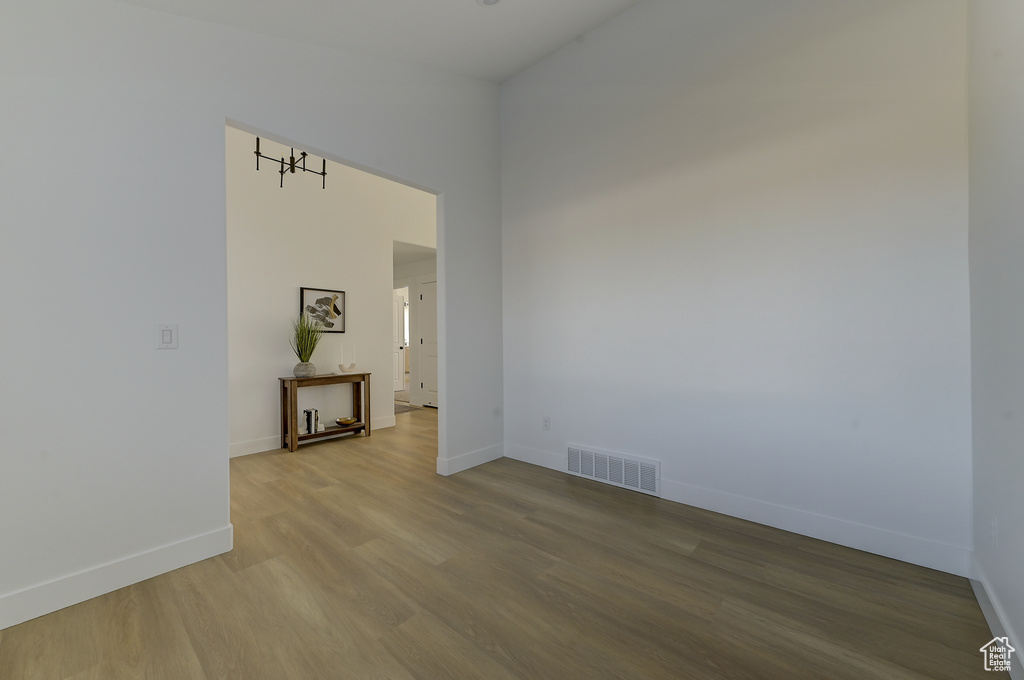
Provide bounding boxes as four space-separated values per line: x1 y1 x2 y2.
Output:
114 0 640 83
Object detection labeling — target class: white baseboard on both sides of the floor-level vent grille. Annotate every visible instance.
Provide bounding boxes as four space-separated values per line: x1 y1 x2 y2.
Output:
505 444 972 577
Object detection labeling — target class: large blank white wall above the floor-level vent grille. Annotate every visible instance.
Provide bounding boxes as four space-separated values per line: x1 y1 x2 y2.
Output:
502 0 972 575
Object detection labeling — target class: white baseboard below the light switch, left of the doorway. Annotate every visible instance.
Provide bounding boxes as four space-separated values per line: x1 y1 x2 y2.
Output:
0 524 233 630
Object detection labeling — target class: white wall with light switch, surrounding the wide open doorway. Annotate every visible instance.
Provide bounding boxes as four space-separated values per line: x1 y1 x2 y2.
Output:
0 0 502 628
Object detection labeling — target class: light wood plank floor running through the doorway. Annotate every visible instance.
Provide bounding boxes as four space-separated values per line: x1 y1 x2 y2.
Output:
0 410 1001 680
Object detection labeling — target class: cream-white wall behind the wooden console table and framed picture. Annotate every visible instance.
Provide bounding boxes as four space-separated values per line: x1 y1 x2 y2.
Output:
226 127 437 456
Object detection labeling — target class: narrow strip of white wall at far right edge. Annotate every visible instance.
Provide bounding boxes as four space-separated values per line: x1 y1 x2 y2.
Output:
970 0 1024 659
